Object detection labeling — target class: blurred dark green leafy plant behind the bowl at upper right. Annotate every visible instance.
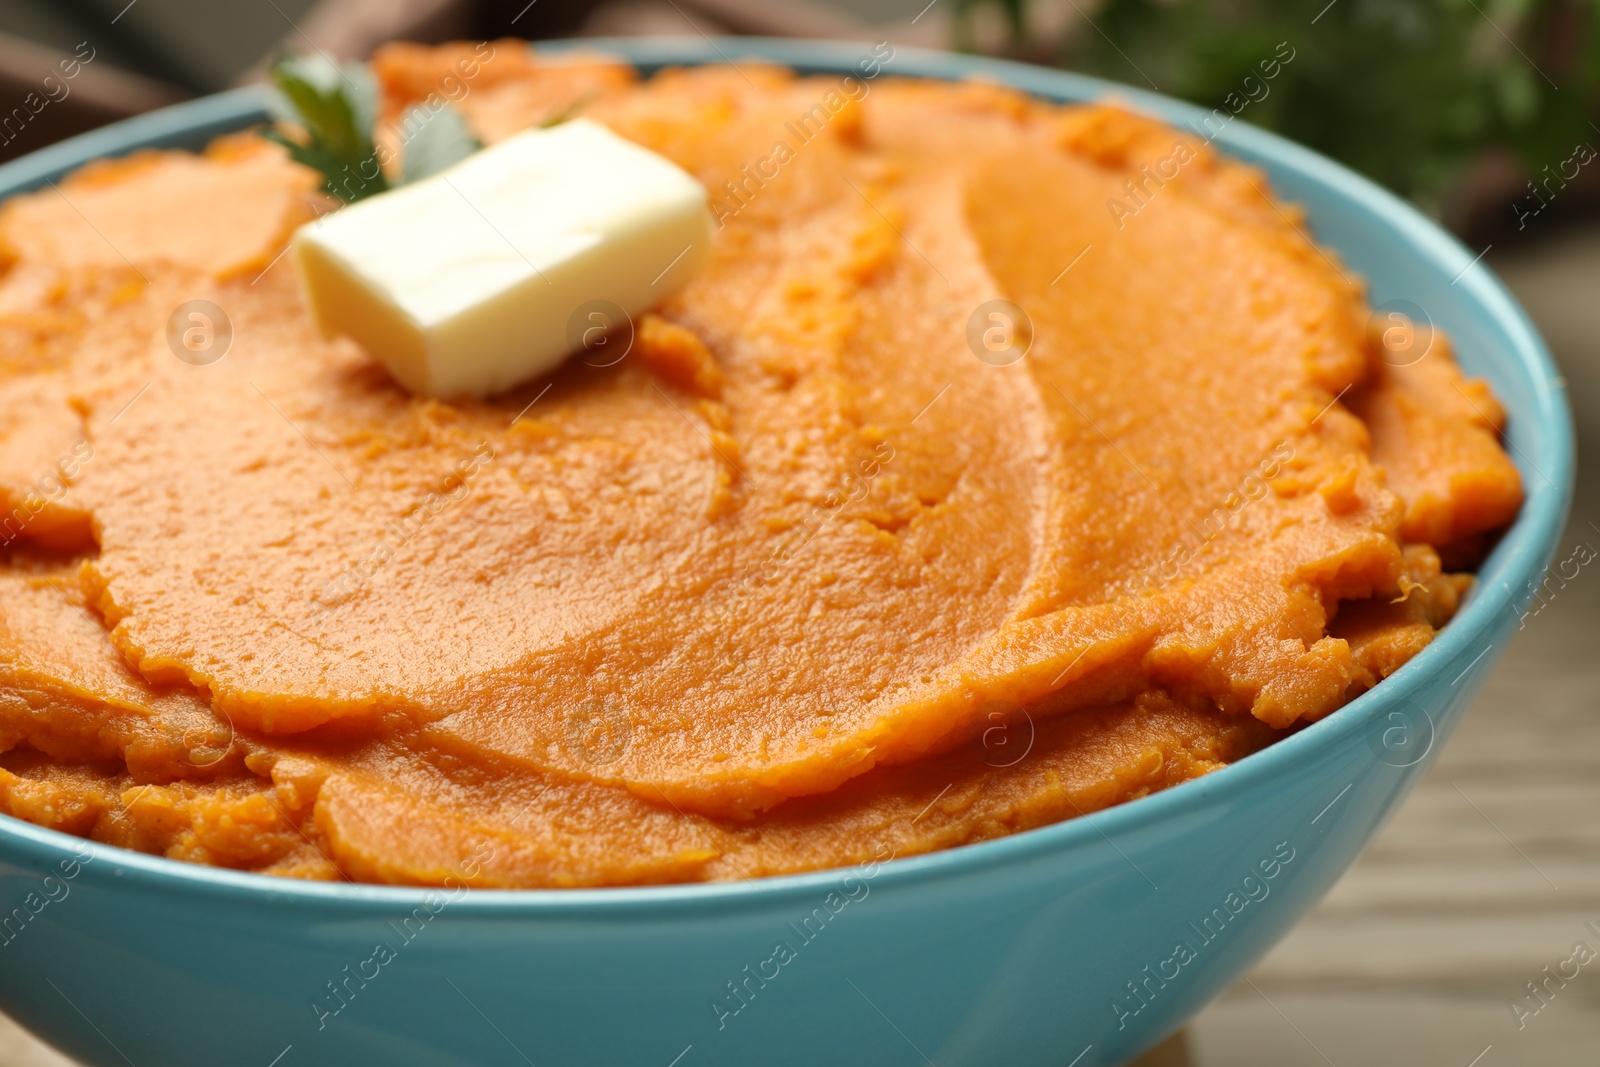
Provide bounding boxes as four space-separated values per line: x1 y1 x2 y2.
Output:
957 0 1600 214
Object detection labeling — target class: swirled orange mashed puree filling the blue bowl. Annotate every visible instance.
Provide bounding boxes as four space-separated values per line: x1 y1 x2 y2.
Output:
0 42 1522 886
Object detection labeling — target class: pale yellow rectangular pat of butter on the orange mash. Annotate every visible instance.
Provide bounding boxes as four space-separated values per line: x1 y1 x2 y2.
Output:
294 118 712 397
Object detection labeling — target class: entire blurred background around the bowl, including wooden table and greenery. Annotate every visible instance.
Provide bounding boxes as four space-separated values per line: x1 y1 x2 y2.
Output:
0 0 1600 1067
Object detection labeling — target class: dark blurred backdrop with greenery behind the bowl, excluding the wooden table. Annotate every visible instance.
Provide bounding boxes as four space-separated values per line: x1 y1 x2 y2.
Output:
9 0 1600 242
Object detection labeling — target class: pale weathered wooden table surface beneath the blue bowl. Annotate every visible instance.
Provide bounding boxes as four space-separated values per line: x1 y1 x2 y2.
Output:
0 227 1600 1067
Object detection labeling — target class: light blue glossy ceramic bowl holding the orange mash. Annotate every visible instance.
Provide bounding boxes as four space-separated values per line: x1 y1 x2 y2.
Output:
0 38 1573 1067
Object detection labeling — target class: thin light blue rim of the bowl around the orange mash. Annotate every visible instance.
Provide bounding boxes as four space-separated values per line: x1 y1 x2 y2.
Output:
0 35 1576 917
